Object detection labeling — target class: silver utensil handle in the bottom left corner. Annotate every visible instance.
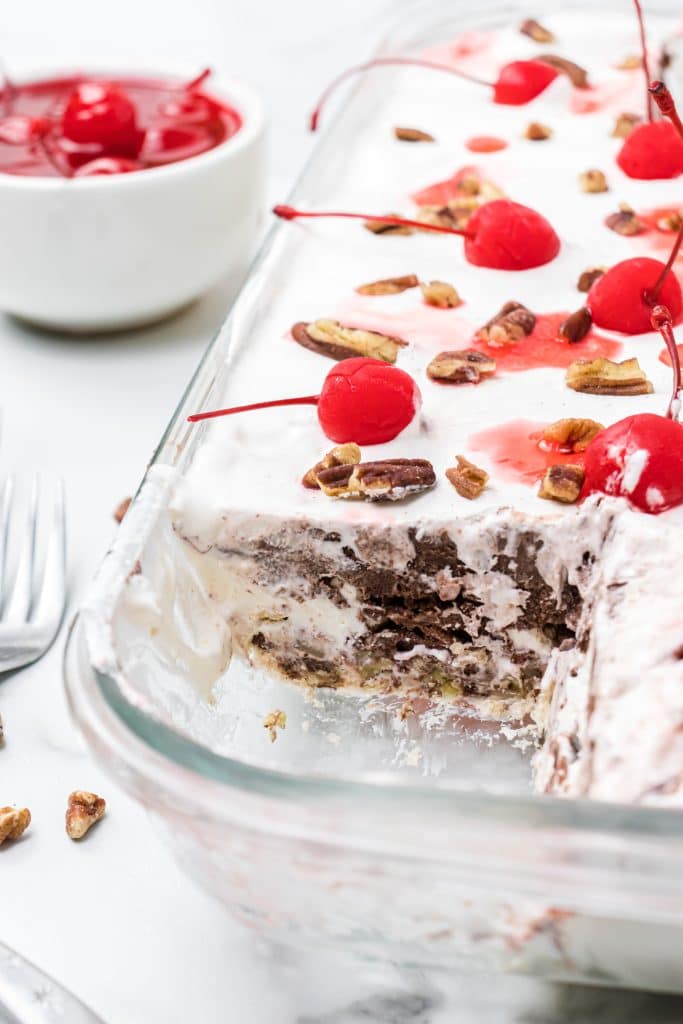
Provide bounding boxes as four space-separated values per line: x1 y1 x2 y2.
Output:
0 942 103 1024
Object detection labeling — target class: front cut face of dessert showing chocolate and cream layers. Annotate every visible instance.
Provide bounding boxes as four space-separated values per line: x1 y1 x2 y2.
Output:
178 501 605 716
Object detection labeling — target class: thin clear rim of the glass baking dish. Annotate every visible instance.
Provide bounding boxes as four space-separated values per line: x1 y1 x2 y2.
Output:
65 0 683 840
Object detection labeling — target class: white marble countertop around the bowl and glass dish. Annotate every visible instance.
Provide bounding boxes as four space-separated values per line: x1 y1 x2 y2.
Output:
0 0 683 1024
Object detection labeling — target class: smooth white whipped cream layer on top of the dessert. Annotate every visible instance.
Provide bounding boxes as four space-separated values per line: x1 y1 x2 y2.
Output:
174 5 683 538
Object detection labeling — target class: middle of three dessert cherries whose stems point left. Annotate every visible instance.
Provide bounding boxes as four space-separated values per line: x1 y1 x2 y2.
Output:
272 199 560 270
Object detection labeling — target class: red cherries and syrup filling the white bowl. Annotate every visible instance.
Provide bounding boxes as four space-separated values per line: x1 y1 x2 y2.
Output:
0 71 242 177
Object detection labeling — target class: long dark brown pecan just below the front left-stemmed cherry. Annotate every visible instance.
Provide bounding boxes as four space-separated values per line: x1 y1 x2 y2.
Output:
317 459 436 501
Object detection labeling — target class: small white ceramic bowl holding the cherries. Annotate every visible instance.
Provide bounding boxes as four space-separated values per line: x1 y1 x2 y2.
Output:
0 67 265 333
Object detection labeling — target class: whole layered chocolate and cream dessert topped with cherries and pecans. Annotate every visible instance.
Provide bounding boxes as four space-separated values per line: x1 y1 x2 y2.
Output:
166 5 683 804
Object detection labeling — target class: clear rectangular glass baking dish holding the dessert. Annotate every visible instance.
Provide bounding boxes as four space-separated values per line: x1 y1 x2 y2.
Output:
66 0 683 991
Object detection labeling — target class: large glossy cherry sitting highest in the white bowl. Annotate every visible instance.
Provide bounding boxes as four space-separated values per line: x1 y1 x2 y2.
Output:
61 82 143 157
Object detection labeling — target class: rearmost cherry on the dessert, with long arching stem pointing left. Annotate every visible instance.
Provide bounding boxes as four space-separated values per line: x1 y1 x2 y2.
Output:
309 57 559 131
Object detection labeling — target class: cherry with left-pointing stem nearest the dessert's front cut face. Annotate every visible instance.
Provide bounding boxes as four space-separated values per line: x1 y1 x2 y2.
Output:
188 356 422 444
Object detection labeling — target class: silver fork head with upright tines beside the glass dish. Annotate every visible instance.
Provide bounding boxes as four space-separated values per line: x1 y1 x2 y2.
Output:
0 476 66 672
